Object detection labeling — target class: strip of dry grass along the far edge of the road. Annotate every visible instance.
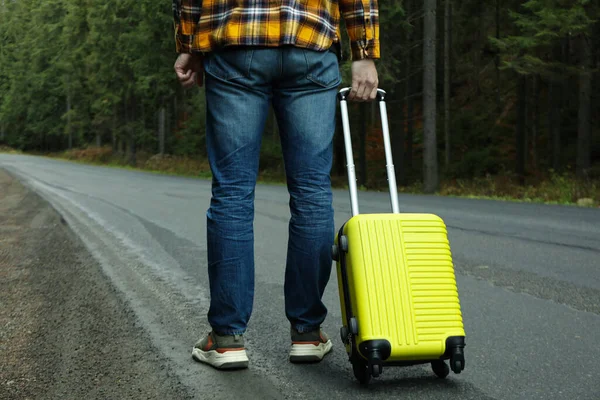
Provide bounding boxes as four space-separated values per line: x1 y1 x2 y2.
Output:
0 147 600 207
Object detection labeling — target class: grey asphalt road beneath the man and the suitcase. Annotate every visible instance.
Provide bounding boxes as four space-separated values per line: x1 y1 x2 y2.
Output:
0 155 600 400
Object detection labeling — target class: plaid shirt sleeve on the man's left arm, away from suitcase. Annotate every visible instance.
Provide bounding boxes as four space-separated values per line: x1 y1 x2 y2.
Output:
173 0 202 53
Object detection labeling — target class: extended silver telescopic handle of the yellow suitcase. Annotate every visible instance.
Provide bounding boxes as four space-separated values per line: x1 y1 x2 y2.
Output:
338 88 400 216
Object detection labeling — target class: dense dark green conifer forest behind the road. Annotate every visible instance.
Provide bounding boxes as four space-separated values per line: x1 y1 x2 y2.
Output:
0 0 600 202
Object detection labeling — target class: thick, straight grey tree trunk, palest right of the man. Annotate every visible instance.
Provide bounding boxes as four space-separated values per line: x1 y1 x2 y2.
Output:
423 0 439 193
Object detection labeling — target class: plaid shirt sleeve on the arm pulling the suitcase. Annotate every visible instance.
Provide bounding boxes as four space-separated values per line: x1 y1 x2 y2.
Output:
340 0 380 60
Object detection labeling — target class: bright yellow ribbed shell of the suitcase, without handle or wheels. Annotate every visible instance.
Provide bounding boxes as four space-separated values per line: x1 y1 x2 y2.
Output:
349 214 464 353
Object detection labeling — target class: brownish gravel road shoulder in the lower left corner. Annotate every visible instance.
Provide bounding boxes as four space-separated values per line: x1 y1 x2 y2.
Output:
0 169 189 399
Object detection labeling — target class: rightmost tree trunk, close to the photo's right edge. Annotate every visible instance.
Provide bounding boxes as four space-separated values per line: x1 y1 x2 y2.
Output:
577 35 592 178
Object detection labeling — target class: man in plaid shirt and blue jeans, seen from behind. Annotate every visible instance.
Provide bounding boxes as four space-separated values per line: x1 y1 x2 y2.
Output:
173 0 380 368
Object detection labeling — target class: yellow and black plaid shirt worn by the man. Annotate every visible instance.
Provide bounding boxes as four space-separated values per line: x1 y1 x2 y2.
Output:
173 0 380 60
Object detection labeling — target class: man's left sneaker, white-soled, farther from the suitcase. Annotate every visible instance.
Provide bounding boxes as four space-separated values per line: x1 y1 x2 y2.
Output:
192 332 248 369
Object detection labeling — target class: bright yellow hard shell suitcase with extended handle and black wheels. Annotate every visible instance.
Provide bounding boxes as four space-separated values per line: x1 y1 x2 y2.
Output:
332 88 465 384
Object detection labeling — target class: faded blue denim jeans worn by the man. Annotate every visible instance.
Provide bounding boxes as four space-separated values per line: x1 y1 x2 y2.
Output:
204 47 341 335
